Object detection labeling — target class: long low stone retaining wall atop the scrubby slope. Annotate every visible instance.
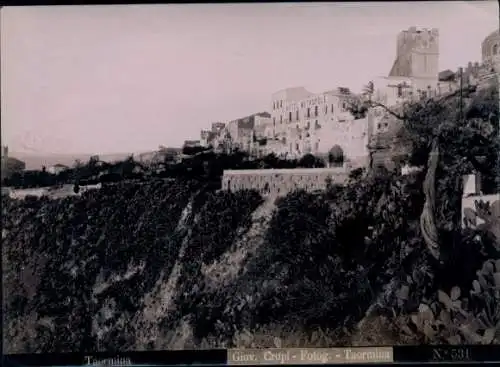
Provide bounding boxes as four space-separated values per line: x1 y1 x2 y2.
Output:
222 167 350 196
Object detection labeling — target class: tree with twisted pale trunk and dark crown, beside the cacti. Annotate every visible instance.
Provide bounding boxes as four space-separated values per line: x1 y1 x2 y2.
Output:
354 82 500 263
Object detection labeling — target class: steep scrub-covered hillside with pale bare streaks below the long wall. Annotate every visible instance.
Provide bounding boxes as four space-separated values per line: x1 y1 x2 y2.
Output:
2 167 496 353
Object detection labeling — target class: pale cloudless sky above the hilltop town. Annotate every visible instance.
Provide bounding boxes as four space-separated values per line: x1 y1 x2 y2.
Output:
1 1 499 154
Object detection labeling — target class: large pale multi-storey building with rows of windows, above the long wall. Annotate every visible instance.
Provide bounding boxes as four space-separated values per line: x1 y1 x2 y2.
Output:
271 87 368 167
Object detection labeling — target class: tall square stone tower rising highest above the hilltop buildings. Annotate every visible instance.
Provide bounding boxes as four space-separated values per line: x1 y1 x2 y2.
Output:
389 27 439 90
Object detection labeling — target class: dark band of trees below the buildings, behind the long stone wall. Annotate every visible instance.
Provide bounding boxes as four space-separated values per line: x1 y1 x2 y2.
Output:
2 147 328 189
